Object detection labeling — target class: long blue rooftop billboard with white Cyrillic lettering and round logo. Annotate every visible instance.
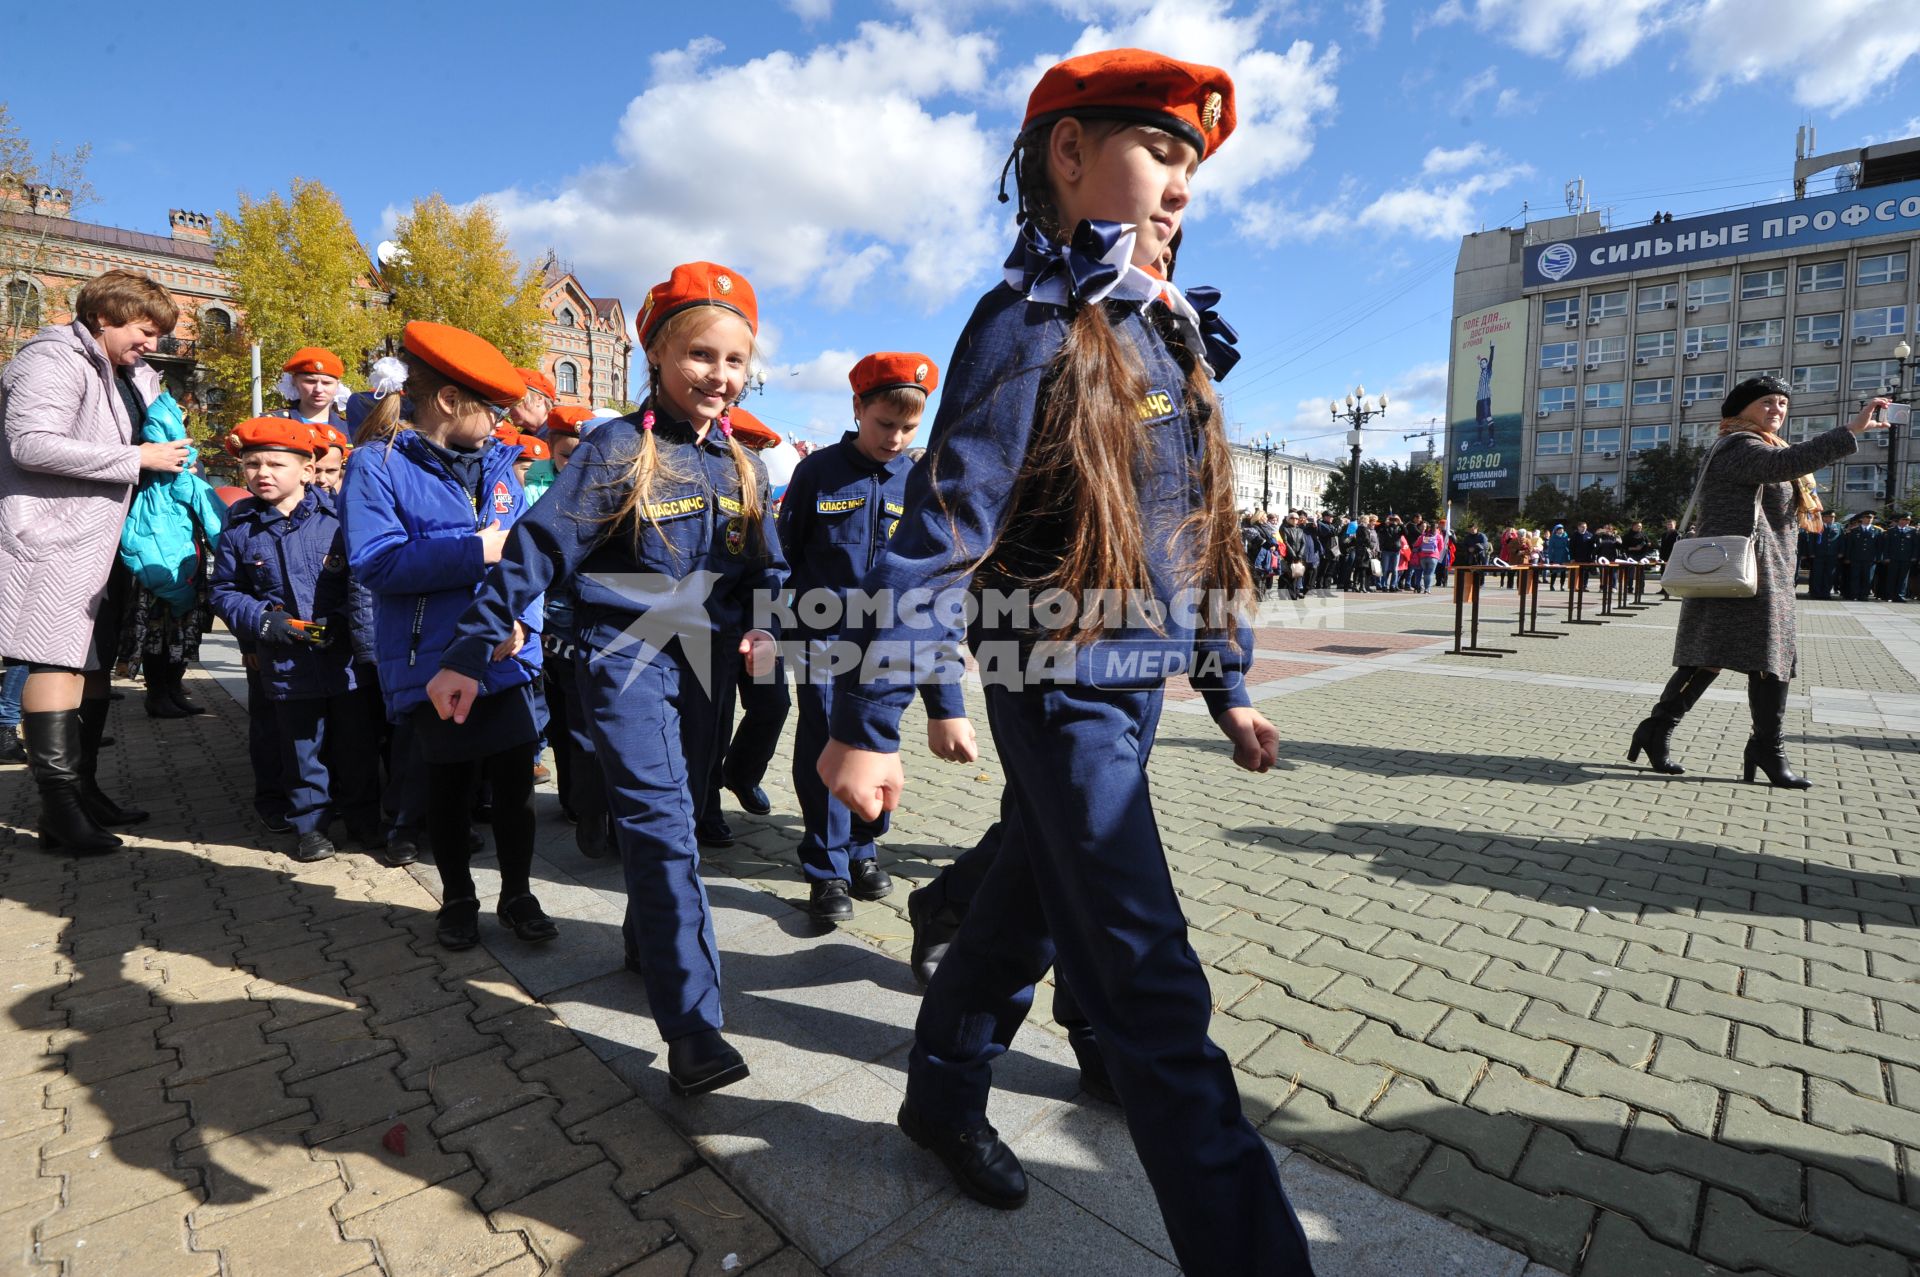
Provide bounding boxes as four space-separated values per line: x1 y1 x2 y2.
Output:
1526 182 1920 288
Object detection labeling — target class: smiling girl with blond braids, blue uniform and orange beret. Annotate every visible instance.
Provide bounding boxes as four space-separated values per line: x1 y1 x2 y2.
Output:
428 261 785 1095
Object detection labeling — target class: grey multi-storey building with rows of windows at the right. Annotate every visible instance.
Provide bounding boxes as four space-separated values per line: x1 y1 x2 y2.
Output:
1446 140 1920 513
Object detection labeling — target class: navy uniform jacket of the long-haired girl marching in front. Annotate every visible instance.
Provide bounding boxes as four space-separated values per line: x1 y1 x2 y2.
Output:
829 284 1252 753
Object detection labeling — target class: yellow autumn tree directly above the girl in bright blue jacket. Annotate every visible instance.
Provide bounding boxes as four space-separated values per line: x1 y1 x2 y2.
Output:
384 194 547 367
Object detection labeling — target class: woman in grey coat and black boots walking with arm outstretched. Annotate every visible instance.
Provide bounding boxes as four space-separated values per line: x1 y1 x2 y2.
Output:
1626 376 1887 789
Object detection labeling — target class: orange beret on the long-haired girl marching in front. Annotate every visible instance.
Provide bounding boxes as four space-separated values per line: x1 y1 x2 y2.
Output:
1020 48 1235 159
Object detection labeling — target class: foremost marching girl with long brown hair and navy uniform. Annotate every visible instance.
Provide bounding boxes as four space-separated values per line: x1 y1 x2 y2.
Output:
820 50 1311 1277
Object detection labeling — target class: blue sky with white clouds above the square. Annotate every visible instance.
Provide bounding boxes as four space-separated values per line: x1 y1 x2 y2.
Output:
0 0 1920 459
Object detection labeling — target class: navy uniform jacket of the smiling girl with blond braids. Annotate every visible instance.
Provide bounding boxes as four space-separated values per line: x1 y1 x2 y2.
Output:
440 409 787 678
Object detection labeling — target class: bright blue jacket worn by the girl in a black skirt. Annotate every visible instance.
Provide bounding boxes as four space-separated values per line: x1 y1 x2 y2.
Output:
340 430 541 718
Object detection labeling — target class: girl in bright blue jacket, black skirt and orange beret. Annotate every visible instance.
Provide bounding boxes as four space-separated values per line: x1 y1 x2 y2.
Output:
342 321 559 949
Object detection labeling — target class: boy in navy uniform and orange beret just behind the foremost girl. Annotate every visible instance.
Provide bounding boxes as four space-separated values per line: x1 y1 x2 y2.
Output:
780 351 973 924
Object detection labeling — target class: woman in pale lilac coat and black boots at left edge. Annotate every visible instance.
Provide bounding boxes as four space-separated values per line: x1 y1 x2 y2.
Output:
0 271 190 853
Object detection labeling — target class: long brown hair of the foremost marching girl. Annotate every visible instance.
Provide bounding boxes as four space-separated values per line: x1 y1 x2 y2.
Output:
929 121 1252 643
